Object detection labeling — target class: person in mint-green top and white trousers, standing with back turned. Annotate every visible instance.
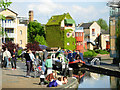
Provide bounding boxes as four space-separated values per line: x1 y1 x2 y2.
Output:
45 55 52 75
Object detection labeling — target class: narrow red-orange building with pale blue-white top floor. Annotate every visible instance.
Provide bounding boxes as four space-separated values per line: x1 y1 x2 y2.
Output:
75 27 85 53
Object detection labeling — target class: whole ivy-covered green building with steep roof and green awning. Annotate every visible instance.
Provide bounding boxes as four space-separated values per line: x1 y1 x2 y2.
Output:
45 13 75 50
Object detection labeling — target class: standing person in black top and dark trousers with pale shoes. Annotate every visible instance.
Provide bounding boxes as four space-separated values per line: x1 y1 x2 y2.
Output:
25 49 32 77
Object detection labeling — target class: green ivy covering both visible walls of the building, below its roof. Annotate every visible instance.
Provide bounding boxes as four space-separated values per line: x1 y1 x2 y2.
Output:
46 26 75 50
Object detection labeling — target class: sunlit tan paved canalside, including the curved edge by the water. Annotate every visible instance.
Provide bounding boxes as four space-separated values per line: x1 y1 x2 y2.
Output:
0 60 78 90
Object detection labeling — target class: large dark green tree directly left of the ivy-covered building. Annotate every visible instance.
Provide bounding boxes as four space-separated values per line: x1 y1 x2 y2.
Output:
28 22 45 43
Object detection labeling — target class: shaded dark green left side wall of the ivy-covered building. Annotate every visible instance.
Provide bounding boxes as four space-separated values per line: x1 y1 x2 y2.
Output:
46 25 64 48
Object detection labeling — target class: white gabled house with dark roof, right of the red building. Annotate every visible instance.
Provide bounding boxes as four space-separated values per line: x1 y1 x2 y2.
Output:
78 22 101 50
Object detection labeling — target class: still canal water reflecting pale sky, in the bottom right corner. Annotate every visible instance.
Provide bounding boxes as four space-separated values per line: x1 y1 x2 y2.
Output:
78 71 120 90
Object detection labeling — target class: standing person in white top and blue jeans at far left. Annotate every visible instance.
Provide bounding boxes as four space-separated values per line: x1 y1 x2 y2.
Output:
3 48 11 68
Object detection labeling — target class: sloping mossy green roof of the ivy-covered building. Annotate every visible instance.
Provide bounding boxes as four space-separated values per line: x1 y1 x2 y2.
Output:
46 13 72 25
